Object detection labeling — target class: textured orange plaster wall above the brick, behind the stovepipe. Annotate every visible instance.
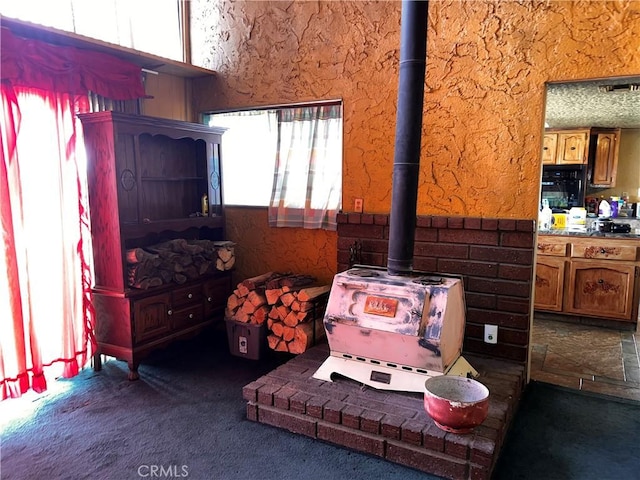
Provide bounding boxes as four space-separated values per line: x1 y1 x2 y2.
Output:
192 0 640 282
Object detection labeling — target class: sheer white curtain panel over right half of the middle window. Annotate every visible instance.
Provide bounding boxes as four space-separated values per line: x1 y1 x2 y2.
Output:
269 105 342 230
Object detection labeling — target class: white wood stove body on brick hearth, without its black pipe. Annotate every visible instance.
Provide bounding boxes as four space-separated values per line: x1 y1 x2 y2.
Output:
314 265 478 392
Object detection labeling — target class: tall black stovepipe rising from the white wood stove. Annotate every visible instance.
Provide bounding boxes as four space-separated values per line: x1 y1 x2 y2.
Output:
387 1 429 275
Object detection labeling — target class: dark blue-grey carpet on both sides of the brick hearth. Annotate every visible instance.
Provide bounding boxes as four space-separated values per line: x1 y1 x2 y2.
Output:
0 330 640 480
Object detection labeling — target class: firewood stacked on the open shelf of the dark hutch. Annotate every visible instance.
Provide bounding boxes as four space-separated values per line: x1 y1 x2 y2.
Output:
125 238 235 289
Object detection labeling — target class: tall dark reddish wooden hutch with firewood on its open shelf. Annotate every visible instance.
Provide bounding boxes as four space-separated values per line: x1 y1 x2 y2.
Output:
80 112 232 380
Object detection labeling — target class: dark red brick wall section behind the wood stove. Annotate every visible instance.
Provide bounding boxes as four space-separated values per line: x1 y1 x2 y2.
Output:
338 213 535 362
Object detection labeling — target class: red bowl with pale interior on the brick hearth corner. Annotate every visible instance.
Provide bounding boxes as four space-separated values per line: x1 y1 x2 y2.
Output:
424 375 489 433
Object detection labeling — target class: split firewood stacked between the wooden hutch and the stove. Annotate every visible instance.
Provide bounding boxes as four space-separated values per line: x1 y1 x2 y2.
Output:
226 272 330 354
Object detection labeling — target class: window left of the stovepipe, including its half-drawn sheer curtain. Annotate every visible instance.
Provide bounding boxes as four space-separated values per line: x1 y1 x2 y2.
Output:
205 102 342 230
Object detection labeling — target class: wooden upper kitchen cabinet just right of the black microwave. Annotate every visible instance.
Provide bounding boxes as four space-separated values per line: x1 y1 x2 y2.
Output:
589 129 620 187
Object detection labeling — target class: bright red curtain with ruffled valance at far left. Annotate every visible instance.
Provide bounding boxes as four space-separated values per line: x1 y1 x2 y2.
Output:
0 29 144 400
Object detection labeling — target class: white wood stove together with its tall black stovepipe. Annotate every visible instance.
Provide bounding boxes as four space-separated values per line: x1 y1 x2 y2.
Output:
314 1 477 392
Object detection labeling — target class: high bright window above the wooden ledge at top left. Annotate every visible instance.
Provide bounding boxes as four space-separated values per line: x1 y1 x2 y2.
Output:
0 0 185 61
